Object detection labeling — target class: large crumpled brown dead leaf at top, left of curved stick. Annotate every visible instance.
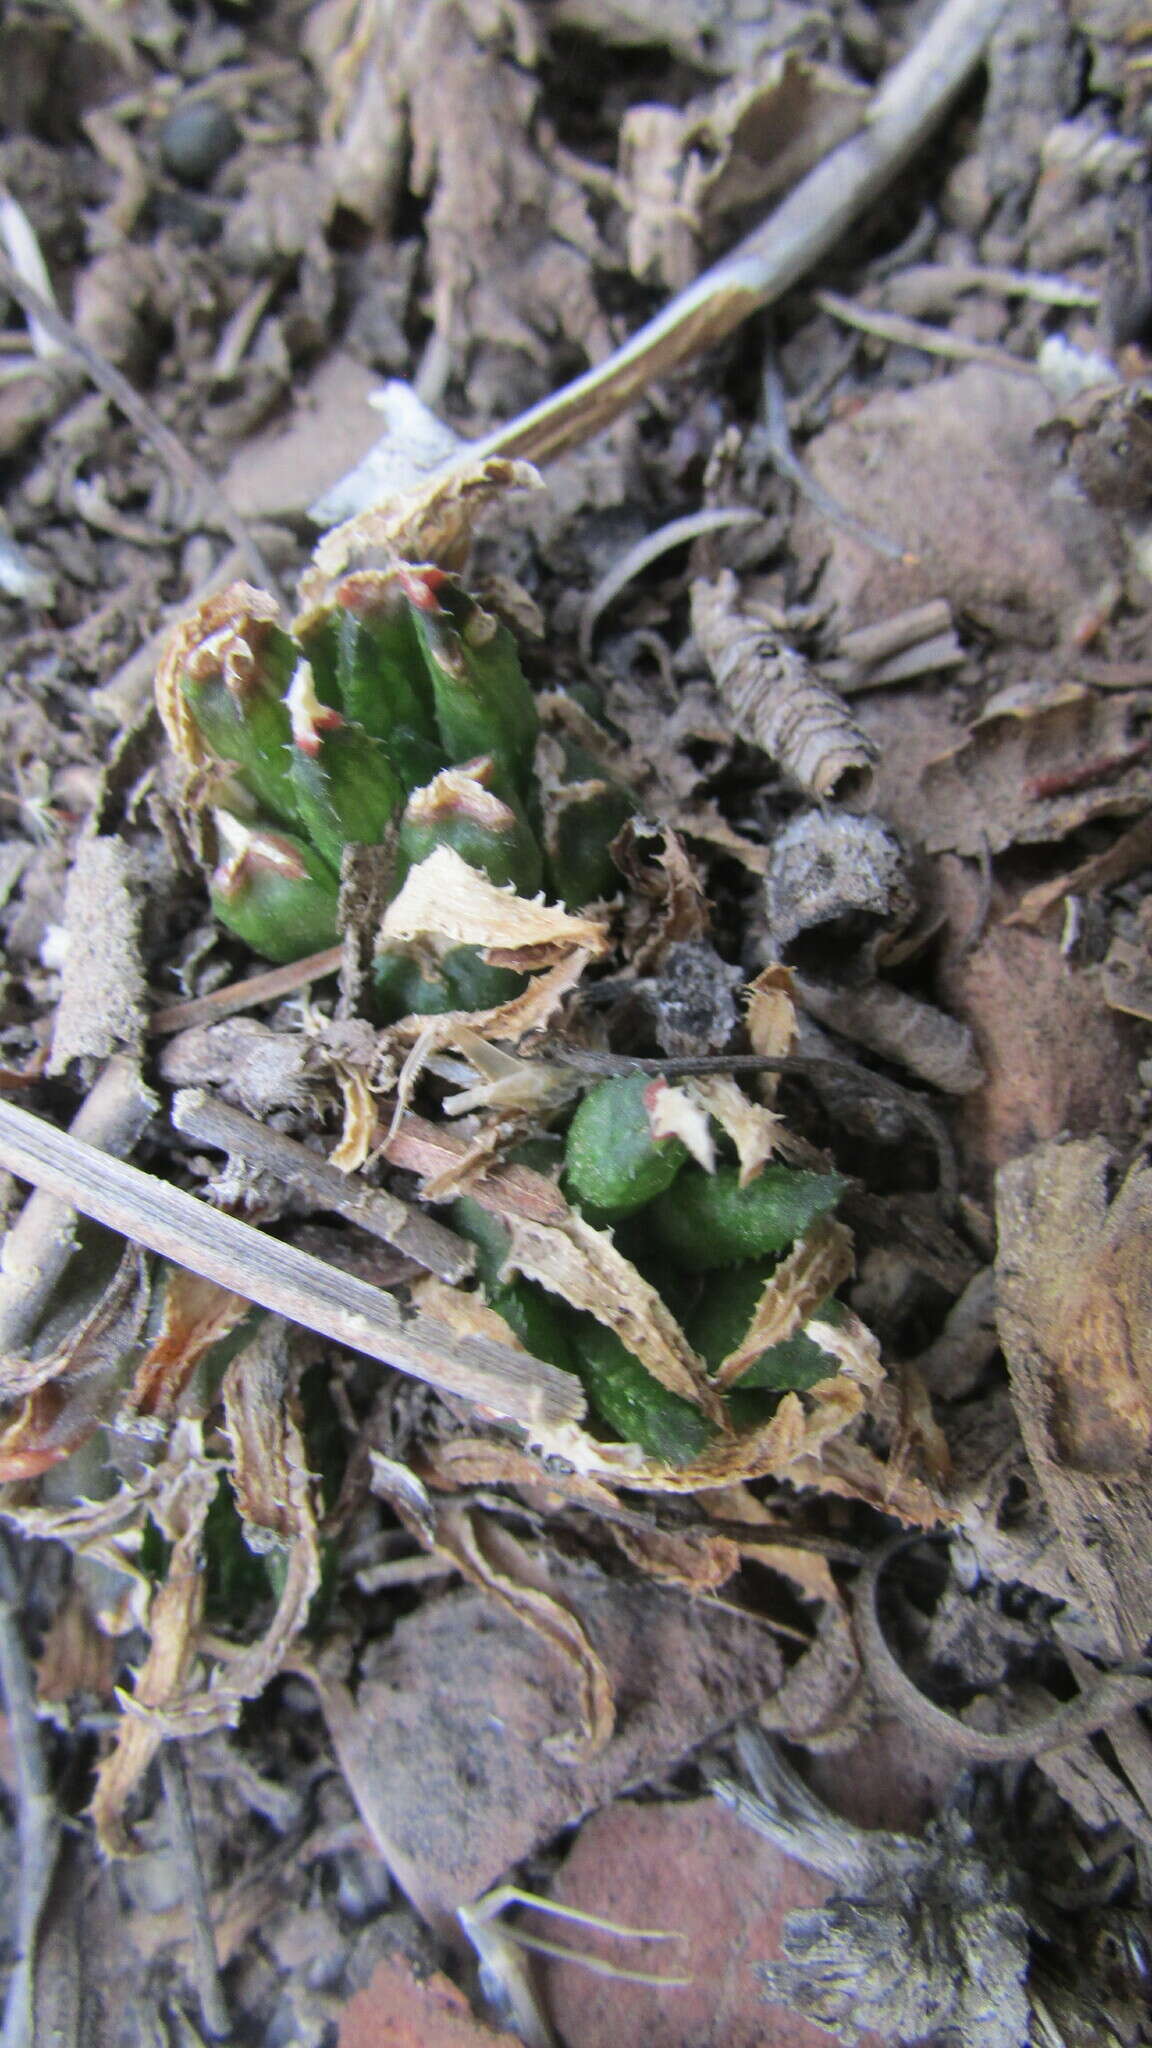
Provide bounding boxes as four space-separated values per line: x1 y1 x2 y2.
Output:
307 0 611 412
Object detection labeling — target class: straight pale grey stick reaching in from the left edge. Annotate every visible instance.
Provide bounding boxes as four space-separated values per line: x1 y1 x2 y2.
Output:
0 1102 584 1430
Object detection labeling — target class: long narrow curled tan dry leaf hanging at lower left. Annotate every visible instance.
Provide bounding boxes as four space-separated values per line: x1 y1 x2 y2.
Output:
90 1421 219 1855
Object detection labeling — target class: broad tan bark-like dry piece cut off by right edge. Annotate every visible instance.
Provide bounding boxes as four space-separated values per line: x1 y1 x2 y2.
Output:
996 1139 1152 1653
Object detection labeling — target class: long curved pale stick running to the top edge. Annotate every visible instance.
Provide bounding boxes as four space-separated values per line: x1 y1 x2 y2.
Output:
461 0 1006 463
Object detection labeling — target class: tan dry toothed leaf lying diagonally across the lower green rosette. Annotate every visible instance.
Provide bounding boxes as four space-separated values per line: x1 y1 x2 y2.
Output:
502 1190 726 1427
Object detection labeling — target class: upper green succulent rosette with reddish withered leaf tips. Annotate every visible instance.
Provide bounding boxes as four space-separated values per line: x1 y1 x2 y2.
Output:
158 563 629 1018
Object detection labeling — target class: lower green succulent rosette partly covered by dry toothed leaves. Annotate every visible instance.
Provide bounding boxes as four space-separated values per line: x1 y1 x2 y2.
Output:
453 1075 845 1464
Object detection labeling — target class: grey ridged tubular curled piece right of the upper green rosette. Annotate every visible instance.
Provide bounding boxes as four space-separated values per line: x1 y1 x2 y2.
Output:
693 569 875 799
